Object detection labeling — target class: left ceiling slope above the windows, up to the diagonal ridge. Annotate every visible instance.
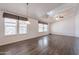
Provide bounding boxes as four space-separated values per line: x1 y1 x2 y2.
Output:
0 3 62 20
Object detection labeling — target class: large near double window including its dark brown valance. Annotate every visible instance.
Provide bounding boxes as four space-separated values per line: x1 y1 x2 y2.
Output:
3 13 29 35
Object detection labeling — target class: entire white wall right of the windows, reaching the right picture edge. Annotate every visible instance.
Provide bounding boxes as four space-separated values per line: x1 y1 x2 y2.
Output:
51 6 79 37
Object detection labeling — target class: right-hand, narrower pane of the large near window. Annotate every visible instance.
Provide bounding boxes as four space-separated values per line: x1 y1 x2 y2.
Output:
19 20 27 34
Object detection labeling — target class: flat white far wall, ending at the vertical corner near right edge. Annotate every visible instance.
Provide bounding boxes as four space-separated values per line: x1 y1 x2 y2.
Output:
51 14 75 36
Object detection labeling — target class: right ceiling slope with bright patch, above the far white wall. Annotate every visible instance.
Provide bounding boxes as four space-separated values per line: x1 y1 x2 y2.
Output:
42 3 79 23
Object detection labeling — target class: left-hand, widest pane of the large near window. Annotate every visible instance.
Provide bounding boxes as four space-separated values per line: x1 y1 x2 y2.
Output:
4 18 17 35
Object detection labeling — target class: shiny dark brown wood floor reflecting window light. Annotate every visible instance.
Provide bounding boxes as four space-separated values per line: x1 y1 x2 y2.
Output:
0 35 79 55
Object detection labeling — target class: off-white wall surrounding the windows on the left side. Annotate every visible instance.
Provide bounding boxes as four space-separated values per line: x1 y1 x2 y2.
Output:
0 11 49 45
